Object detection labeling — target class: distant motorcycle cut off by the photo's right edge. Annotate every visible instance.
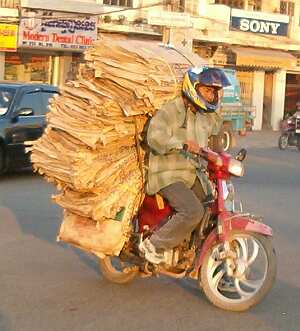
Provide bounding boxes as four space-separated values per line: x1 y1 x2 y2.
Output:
278 111 300 151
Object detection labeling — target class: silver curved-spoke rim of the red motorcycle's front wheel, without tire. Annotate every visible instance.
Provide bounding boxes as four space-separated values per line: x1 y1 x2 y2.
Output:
207 234 269 304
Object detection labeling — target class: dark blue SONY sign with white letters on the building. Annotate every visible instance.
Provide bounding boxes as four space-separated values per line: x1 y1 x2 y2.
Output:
230 9 289 36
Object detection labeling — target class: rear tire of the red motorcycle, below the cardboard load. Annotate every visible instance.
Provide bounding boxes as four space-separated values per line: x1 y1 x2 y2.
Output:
99 256 139 284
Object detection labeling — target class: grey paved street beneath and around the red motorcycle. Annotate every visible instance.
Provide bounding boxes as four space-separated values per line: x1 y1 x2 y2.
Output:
0 132 300 331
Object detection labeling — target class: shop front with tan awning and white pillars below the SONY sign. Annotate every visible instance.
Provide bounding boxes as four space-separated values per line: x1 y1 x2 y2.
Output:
231 47 296 130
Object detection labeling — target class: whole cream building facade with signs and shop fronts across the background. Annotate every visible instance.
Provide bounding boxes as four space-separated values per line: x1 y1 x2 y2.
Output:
0 0 300 130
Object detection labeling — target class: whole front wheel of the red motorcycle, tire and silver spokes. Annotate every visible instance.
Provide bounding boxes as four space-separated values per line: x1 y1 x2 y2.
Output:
199 232 277 311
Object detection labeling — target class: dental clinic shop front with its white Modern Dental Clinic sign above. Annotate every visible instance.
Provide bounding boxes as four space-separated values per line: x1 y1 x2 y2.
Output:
4 9 97 85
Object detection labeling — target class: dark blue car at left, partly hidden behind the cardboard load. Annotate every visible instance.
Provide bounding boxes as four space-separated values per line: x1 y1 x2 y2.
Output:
0 82 59 173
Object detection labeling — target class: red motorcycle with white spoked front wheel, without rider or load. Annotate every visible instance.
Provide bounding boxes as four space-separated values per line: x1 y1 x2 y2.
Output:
100 148 276 311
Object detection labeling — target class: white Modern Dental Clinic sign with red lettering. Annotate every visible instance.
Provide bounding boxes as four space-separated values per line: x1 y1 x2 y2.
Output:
18 9 97 51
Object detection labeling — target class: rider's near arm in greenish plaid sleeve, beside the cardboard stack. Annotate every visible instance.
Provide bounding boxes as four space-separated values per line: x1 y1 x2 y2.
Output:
147 105 186 154
